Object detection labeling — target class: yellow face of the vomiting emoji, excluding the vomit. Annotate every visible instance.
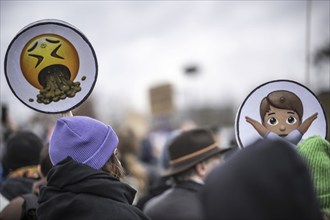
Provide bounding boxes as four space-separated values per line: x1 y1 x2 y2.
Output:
20 34 79 89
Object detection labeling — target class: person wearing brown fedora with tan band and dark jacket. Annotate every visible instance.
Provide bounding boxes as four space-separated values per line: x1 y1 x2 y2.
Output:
143 128 229 220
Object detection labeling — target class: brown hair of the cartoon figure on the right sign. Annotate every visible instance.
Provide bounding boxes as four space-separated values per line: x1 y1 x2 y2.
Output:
259 90 304 121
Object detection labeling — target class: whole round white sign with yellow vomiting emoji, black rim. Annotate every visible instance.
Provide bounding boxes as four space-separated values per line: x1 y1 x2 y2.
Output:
5 20 97 113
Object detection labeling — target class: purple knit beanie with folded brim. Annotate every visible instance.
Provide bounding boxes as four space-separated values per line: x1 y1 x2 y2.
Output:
49 116 118 170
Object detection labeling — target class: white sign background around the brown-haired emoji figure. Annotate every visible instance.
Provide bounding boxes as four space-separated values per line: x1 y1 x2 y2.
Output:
235 80 327 148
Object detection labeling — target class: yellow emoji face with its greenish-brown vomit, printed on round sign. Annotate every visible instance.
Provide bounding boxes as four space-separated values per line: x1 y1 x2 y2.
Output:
20 34 81 104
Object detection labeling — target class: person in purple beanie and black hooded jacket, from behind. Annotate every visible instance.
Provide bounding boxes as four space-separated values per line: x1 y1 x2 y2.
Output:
37 116 149 220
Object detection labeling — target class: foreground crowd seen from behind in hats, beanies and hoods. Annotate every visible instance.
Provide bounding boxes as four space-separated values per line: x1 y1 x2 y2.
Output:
0 109 330 220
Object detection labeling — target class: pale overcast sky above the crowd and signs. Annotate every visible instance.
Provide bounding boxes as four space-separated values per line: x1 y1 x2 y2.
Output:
1 0 330 124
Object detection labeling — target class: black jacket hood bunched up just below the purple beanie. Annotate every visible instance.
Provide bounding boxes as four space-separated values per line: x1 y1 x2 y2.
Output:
41 157 136 204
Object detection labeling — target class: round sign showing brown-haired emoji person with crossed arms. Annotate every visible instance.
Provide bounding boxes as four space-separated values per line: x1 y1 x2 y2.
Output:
235 80 327 147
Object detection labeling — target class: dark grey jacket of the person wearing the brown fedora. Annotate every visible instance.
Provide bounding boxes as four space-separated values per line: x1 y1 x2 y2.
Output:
144 181 203 220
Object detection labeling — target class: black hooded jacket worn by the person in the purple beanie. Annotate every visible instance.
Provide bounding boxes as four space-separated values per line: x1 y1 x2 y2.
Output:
37 157 149 220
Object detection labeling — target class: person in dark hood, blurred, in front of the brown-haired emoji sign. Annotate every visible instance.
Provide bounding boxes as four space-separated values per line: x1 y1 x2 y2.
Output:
201 139 322 220
